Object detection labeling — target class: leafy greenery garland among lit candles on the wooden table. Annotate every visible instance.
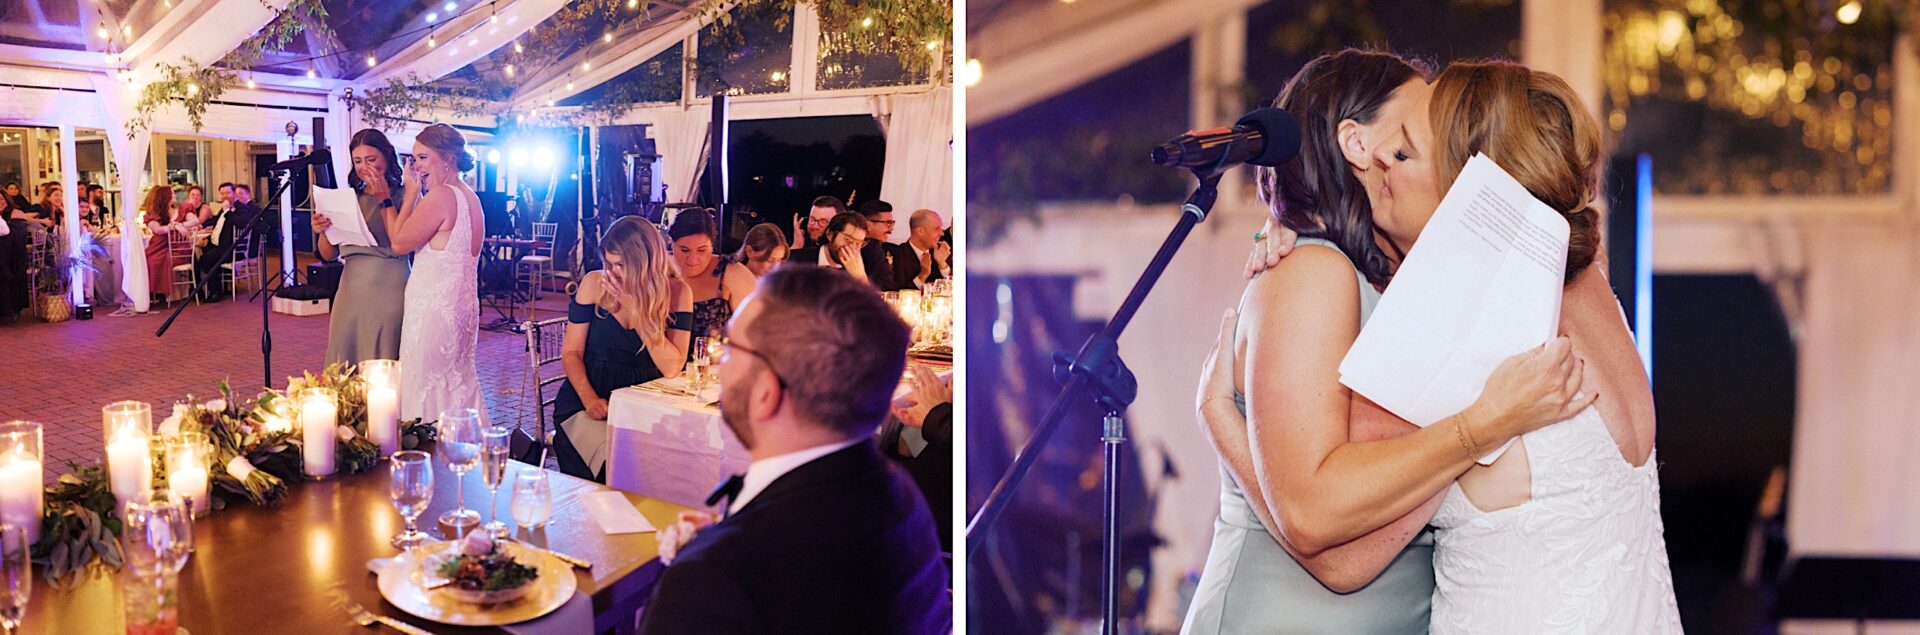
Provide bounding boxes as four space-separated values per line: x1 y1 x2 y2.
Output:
33 365 434 587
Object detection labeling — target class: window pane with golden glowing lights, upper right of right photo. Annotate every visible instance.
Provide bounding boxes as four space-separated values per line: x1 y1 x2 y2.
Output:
1605 0 1897 196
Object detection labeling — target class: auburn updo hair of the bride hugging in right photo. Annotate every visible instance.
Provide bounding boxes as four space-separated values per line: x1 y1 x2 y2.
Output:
1428 59 1601 282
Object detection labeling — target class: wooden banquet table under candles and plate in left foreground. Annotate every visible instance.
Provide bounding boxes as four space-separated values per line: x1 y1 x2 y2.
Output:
19 450 684 635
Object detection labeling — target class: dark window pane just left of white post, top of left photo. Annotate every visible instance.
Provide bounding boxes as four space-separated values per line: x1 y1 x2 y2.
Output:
695 2 793 96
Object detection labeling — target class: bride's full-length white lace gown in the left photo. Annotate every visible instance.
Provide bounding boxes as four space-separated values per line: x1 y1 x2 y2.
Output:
399 192 488 424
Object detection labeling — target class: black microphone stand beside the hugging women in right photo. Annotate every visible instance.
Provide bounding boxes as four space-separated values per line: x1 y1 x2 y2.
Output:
966 165 1227 635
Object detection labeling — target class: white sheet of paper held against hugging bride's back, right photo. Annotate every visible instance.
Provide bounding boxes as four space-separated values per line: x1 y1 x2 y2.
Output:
1340 155 1569 464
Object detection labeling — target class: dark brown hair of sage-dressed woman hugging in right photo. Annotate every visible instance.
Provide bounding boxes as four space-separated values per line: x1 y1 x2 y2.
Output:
1256 48 1427 284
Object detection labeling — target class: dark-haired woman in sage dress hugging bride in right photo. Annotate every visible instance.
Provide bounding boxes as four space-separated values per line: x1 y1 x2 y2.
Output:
1183 50 1572 633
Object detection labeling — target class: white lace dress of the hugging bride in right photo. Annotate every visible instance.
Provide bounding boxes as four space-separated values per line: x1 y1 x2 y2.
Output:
1432 407 1680 633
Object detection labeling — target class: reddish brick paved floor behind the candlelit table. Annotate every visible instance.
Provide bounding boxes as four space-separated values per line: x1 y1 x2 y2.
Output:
0 260 566 476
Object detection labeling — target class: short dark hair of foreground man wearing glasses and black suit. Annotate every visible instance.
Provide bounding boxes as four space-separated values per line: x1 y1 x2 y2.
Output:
747 265 908 435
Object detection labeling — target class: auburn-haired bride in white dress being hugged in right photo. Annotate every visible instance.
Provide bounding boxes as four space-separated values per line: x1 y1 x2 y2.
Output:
1208 61 1680 633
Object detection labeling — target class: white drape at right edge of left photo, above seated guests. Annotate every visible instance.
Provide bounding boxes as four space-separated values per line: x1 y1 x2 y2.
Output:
876 86 954 240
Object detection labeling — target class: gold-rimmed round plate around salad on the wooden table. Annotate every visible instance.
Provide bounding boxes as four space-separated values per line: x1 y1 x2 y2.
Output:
378 543 578 625
